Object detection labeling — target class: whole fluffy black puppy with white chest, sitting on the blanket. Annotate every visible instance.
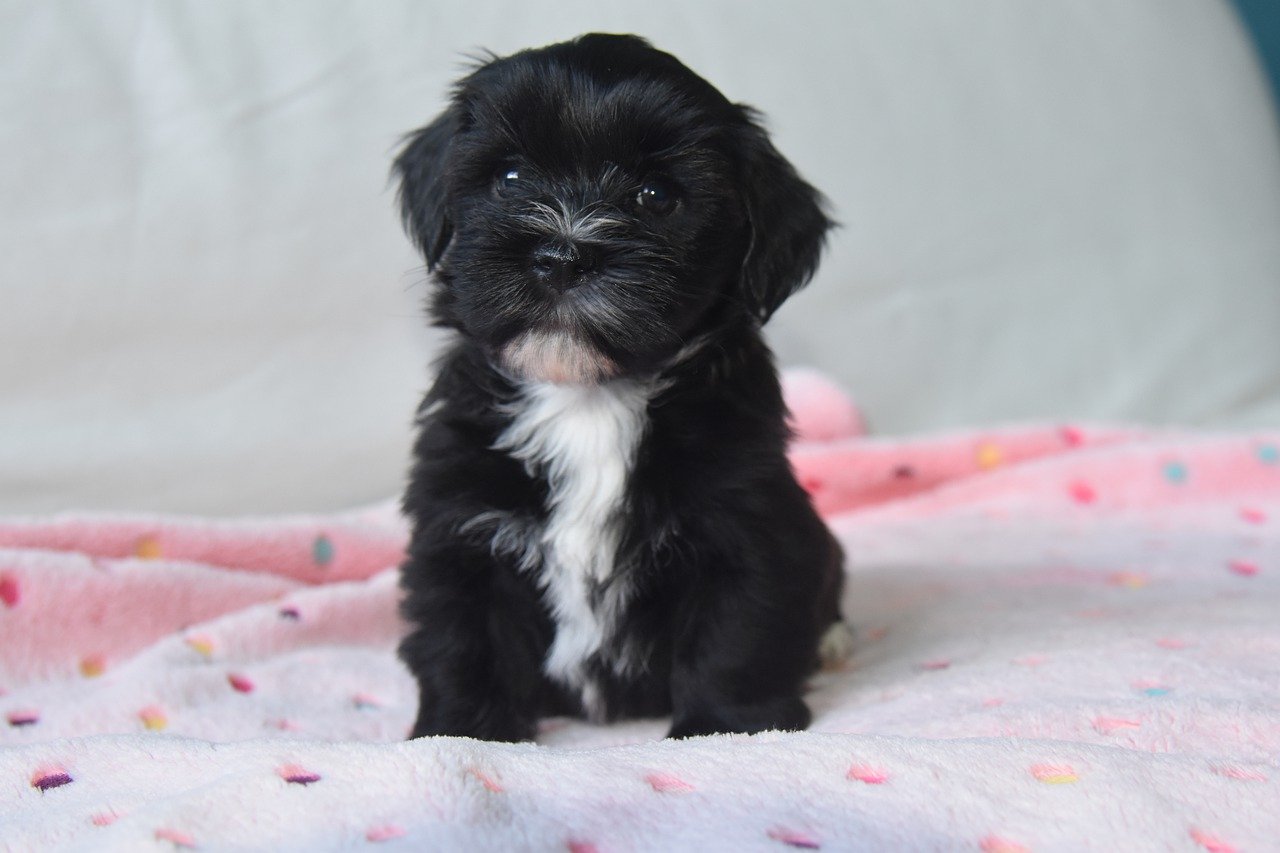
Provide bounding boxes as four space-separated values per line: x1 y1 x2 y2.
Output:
396 35 847 740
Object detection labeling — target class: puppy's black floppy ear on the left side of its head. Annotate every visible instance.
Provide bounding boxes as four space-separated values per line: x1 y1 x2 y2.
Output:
392 106 458 269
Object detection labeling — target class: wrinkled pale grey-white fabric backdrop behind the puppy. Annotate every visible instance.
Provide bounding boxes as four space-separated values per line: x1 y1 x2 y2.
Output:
0 0 1280 514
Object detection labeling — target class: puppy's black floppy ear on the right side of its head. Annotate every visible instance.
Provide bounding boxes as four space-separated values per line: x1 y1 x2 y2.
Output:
736 106 835 323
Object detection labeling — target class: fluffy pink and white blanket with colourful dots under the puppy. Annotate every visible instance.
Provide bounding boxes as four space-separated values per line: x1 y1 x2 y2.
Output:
0 374 1280 853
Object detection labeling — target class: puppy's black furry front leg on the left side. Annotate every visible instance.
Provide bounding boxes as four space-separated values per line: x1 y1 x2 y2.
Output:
399 538 547 740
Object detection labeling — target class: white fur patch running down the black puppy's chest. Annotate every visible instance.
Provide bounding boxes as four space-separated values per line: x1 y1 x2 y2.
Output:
495 380 653 713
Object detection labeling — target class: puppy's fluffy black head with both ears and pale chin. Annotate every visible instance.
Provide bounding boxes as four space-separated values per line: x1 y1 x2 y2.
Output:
396 35 829 384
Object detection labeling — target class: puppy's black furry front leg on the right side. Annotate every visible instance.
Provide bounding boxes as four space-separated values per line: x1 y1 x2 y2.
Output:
667 579 813 738
